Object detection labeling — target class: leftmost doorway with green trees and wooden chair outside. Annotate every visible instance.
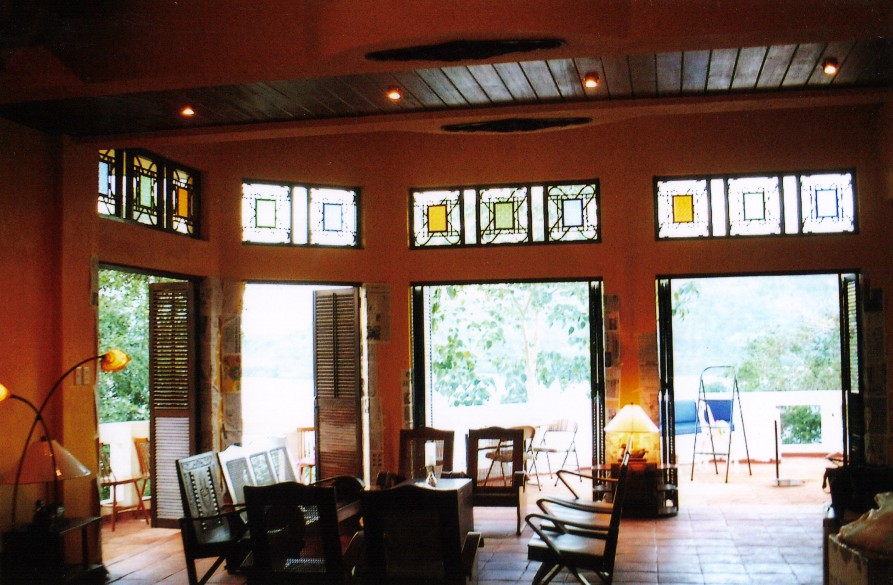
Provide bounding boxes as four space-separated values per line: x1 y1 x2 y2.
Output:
97 266 192 530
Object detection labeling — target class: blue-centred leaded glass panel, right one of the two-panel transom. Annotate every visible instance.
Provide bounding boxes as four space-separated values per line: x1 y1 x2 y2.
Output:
308 187 357 246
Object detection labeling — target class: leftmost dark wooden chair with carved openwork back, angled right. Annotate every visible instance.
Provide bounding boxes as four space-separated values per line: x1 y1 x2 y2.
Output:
177 451 248 585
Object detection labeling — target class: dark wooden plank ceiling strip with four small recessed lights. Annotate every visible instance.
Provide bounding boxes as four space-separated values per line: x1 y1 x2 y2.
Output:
0 38 893 137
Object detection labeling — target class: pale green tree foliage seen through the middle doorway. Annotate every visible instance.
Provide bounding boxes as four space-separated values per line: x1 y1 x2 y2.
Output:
428 283 590 406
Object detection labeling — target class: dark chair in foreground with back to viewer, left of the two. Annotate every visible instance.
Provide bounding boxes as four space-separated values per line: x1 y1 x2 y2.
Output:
245 482 357 585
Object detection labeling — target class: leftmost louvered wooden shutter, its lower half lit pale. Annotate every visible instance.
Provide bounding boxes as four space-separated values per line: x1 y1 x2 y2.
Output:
149 282 195 528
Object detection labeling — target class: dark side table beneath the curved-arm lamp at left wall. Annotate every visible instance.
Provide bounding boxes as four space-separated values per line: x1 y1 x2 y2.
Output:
0 516 106 585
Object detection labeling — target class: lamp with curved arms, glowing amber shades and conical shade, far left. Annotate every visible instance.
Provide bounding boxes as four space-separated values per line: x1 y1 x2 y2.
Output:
0 349 130 529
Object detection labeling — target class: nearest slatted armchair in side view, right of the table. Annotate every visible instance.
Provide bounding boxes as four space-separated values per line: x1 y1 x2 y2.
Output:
526 453 629 585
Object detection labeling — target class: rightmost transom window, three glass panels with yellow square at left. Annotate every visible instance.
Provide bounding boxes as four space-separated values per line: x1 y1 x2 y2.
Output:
654 171 857 239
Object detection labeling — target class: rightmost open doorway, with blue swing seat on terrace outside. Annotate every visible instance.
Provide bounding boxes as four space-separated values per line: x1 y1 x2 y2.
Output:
659 273 855 501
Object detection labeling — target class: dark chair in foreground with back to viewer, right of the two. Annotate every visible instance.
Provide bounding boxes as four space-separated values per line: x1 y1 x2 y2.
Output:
361 484 481 585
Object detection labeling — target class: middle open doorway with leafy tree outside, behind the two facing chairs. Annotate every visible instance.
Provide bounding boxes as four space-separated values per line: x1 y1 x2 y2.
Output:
413 281 604 473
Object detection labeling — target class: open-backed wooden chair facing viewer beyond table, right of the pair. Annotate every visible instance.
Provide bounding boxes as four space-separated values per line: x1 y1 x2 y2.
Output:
466 427 526 534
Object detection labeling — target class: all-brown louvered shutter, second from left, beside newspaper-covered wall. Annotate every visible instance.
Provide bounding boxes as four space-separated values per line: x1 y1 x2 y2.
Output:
313 288 363 478
